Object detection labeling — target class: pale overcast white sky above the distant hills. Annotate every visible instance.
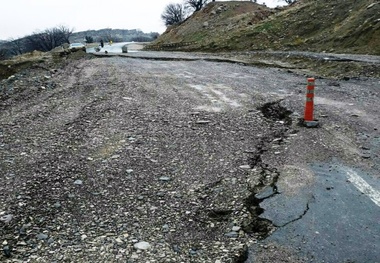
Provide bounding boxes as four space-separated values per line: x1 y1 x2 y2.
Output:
0 0 281 40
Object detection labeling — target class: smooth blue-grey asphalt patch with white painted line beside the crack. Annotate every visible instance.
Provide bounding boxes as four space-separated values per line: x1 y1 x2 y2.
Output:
247 163 380 263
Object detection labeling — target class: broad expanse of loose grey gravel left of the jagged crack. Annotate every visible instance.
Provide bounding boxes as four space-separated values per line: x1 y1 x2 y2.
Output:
0 54 376 262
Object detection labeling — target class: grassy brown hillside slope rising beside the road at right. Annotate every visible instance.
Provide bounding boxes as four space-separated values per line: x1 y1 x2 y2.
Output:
152 0 380 55
